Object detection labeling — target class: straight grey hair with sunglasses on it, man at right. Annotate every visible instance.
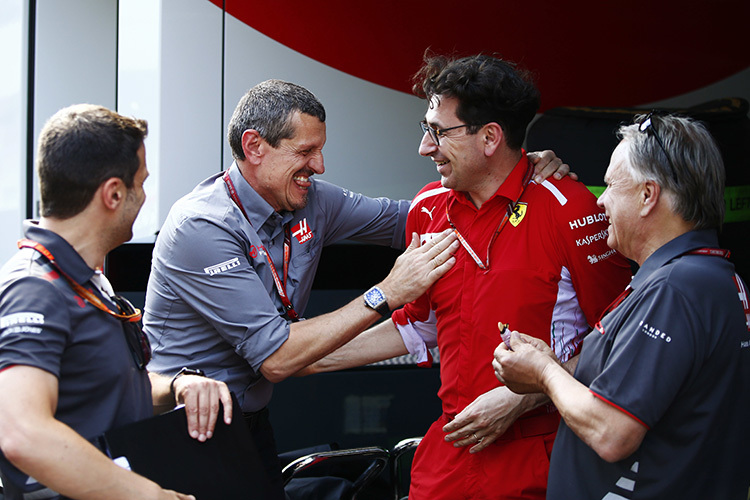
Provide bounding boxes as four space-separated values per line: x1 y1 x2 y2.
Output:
617 115 726 230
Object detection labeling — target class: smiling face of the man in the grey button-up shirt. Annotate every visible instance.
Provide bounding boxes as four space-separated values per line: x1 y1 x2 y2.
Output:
253 111 326 212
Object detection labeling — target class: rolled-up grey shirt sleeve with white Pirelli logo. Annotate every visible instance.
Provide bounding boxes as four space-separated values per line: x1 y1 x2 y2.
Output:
153 217 289 371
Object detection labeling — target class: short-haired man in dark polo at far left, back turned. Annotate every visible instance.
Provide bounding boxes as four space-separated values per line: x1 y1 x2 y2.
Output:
0 105 231 500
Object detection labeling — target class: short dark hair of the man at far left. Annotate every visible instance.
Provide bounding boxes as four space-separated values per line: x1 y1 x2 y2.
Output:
37 104 148 219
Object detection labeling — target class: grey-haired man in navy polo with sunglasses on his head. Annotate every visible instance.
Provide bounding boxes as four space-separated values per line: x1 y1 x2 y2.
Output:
493 115 750 500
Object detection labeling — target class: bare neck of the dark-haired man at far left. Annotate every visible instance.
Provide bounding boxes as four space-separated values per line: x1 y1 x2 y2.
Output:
39 214 116 269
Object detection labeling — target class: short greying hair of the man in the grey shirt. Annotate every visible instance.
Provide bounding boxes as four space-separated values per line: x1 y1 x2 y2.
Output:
227 80 326 160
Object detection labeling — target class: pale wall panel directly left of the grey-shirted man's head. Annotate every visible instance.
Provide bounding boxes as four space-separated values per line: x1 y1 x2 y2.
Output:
157 0 224 222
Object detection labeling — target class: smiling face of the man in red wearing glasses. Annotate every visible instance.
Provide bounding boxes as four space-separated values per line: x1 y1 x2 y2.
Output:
419 97 487 198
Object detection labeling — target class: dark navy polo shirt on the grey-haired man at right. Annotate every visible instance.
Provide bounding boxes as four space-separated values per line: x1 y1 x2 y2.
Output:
547 231 750 500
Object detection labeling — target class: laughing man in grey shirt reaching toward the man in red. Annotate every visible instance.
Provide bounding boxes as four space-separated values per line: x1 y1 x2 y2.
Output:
145 80 567 496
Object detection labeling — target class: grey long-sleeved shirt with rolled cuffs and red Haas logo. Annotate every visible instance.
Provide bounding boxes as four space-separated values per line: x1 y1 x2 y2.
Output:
144 164 409 411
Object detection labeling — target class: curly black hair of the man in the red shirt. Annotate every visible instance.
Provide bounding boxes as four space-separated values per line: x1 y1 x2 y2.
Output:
412 51 539 149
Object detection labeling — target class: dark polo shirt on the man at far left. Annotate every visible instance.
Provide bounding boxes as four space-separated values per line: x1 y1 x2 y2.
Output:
0 223 153 488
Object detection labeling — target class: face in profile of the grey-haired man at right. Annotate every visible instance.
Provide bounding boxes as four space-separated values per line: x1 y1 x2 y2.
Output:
597 141 641 259
